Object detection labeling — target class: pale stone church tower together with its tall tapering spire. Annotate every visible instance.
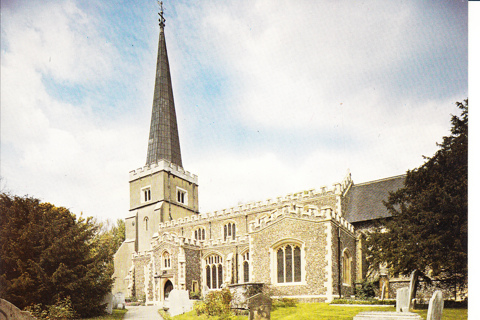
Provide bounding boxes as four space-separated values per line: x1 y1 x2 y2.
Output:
113 4 198 292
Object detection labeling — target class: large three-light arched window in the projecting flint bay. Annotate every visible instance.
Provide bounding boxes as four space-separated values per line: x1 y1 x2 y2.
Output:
275 244 302 283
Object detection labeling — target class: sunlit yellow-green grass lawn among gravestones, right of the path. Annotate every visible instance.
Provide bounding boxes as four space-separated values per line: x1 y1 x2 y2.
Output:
173 303 468 320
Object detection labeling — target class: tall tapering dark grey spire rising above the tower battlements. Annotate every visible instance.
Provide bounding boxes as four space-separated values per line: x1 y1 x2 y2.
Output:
147 2 183 167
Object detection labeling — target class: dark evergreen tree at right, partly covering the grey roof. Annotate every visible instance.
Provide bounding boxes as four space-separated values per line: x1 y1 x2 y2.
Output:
367 100 468 288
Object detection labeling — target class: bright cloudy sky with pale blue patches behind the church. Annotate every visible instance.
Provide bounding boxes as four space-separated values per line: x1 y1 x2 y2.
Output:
0 0 468 224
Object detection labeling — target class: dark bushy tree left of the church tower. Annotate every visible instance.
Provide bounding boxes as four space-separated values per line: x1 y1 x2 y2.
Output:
0 194 112 316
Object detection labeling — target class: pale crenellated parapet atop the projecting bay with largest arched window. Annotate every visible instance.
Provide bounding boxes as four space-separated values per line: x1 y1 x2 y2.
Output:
248 204 353 232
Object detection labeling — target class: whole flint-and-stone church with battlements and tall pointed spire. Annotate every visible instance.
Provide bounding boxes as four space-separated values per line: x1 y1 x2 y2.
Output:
112 6 405 304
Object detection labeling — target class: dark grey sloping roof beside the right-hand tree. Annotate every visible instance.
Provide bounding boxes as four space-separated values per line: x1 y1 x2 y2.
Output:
344 175 406 223
